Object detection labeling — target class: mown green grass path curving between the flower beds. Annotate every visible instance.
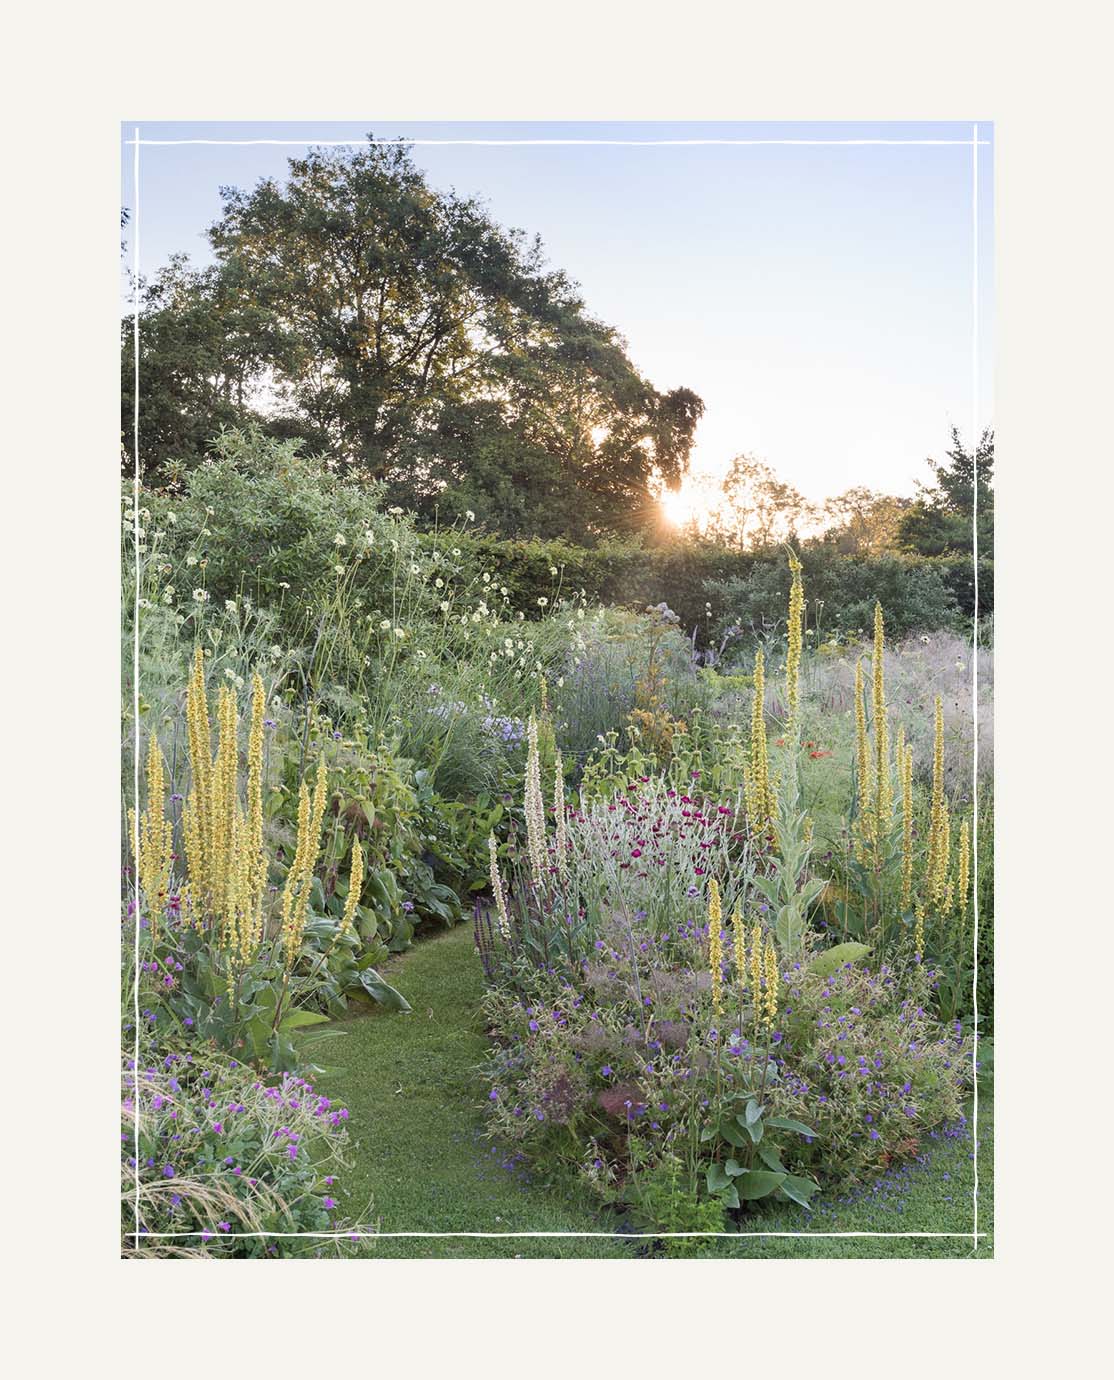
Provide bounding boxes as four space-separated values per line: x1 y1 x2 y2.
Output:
316 925 991 1260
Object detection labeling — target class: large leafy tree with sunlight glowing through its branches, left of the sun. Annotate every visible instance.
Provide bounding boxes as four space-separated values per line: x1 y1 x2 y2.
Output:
126 133 703 537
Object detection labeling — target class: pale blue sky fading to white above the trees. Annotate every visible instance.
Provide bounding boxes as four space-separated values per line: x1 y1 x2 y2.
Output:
121 117 994 518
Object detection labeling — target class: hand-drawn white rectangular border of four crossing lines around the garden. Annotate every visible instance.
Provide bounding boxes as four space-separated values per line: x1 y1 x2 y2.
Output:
127 121 990 1253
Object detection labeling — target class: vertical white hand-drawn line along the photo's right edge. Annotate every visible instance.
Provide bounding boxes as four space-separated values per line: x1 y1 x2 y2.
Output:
970 124 979 1248
